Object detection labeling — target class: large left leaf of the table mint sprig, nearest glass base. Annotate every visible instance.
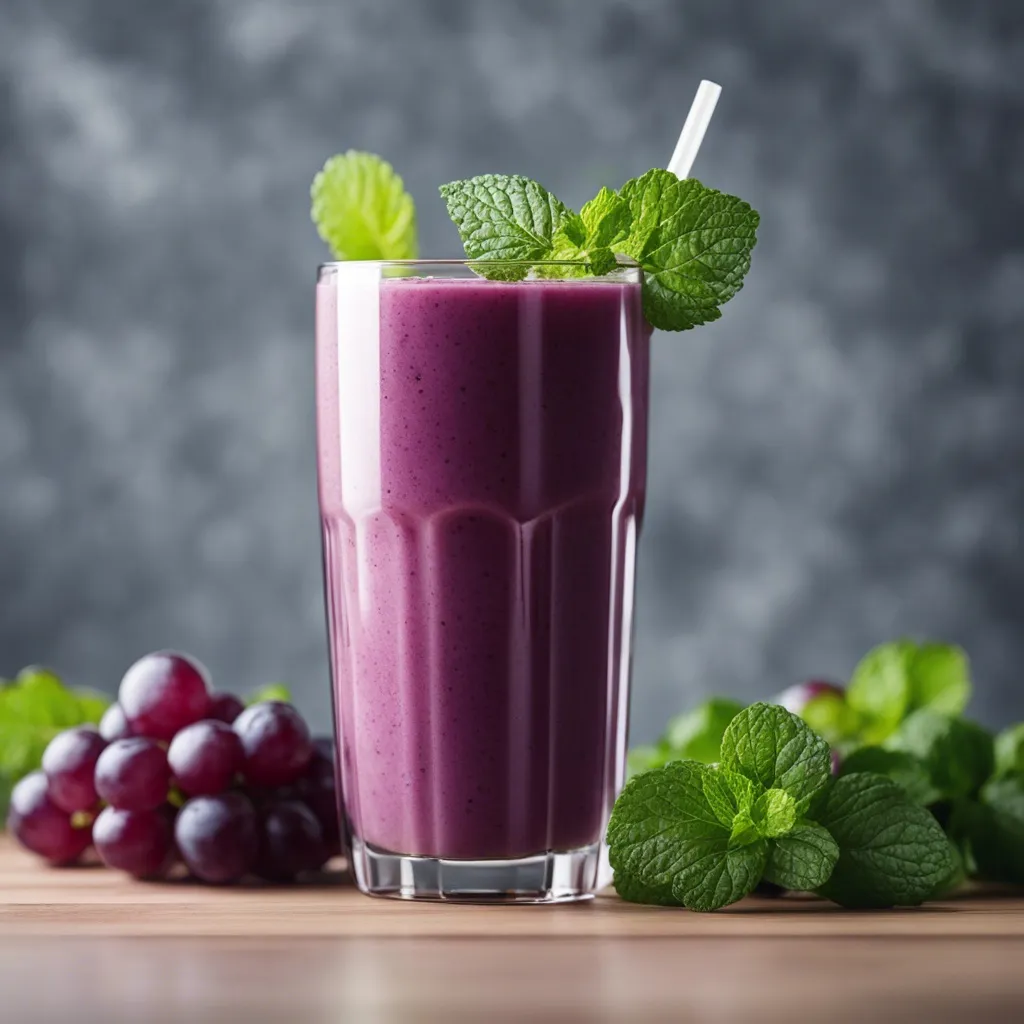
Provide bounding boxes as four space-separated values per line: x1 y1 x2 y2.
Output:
607 761 767 910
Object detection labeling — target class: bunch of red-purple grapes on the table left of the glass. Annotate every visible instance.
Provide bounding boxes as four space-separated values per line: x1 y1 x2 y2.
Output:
7 651 340 884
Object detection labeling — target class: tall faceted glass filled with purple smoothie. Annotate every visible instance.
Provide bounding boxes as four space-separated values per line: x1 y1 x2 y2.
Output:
316 261 649 902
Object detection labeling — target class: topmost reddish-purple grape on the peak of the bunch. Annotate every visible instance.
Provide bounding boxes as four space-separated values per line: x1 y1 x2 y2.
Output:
118 650 210 741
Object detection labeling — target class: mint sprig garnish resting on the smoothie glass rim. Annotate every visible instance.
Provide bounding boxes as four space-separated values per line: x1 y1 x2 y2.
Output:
440 169 759 331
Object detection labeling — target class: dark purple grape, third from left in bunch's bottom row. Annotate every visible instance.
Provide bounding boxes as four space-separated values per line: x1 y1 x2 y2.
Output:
174 793 259 885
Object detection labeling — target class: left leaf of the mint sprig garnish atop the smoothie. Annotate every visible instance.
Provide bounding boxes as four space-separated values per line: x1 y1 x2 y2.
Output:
440 174 571 262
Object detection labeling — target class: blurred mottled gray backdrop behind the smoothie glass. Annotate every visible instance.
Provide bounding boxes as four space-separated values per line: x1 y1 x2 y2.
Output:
0 0 1024 738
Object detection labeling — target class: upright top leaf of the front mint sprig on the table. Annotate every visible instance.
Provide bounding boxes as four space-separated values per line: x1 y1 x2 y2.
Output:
722 703 831 812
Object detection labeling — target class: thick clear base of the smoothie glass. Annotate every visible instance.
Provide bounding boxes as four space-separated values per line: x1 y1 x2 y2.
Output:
348 836 601 903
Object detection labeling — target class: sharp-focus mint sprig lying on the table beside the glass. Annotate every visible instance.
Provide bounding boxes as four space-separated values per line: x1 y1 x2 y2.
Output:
607 703 955 910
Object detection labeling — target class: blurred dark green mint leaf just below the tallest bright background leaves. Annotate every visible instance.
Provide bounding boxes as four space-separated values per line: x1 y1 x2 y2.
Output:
885 708 995 800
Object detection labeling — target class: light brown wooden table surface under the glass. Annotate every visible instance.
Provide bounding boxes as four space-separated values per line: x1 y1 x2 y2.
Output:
0 838 1024 1024
